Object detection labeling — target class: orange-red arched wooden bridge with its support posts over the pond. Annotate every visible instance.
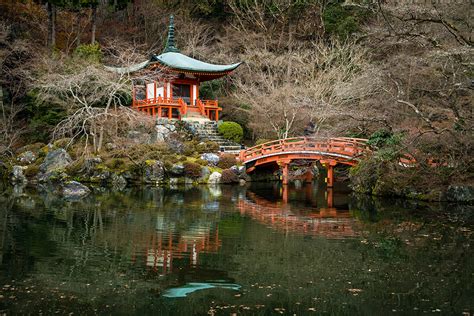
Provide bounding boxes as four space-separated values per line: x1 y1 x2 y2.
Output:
239 137 371 187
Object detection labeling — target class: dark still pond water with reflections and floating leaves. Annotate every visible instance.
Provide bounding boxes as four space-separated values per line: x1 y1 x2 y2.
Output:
0 184 474 315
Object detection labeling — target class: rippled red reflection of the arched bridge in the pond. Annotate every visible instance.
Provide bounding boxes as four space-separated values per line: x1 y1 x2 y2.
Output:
238 192 359 239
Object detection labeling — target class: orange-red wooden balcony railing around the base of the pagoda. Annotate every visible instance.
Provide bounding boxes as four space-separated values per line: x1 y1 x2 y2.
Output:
132 97 222 121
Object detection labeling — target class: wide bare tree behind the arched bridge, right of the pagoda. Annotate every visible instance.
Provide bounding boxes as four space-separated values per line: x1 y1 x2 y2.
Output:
234 42 381 138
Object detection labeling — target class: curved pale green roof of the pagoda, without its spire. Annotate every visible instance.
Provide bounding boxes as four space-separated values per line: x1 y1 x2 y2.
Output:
150 52 241 74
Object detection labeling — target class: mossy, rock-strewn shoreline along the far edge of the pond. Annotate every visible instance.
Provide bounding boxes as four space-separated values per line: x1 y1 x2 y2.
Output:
0 145 474 204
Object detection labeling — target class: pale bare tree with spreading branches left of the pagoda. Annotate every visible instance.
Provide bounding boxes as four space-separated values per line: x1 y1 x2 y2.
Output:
34 44 160 152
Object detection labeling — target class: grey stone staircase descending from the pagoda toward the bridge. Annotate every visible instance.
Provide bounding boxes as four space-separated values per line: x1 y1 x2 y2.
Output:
187 119 241 154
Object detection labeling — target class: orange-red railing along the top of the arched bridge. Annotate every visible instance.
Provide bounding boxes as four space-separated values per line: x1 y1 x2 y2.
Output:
239 137 370 162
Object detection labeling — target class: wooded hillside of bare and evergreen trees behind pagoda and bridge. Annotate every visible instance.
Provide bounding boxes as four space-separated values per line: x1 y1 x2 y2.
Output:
0 0 474 198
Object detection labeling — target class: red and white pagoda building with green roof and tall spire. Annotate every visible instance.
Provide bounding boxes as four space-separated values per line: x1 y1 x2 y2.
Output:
109 16 241 121
